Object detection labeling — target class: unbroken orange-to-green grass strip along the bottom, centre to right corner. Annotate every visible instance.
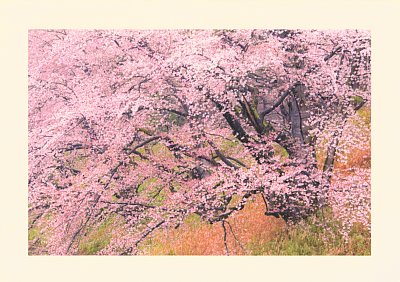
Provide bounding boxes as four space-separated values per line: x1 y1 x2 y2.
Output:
141 198 371 256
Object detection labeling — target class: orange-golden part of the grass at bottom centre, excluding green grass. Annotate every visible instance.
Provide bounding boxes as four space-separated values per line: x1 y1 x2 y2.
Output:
143 195 285 255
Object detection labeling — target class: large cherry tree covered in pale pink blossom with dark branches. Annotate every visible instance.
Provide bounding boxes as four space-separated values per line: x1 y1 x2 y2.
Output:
28 30 370 254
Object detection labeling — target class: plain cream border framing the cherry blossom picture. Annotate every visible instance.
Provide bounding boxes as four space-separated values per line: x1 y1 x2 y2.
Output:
0 0 400 282
